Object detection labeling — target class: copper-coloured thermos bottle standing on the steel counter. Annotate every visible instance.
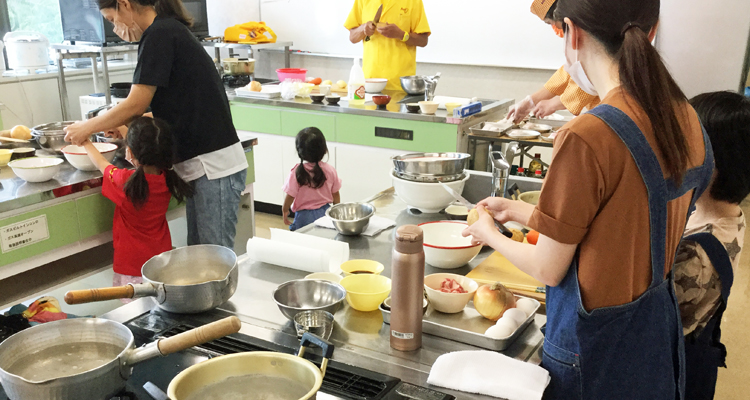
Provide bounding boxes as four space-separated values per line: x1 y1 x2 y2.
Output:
391 225 424 351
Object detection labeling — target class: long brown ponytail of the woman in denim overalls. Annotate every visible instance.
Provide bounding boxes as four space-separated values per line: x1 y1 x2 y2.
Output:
615 23 689 182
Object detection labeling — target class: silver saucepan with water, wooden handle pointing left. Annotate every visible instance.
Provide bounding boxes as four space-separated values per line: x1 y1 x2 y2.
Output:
65 244 238 314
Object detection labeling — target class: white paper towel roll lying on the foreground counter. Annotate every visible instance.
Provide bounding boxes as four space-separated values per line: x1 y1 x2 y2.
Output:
247 237 332 272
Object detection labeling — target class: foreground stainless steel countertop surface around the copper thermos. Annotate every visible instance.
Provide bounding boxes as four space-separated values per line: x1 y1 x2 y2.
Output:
103 189 547 399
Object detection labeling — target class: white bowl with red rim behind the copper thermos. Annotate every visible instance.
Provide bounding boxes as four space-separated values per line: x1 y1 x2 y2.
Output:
419 221 482 269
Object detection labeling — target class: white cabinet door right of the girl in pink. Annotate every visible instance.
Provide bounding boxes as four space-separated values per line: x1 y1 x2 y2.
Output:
335 143 404 202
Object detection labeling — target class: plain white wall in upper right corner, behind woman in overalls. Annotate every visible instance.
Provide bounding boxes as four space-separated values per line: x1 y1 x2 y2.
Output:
657 0 750 97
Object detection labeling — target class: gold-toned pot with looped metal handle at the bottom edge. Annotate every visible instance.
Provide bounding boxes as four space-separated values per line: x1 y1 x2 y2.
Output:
167 332 333 400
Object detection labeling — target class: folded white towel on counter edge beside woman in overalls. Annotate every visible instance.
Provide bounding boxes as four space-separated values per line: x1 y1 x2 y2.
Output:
427 350 550 400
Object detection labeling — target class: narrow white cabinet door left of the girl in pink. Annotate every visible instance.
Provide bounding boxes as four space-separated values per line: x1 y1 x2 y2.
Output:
244 133 286 205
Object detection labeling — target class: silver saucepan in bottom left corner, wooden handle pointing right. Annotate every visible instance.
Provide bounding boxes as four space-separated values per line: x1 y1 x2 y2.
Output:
0 317 242 400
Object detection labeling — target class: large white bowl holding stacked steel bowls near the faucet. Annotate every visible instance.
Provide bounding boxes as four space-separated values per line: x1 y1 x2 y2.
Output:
391 172 469 213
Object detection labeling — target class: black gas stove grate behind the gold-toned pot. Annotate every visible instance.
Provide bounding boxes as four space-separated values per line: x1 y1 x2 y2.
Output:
161 324 398 400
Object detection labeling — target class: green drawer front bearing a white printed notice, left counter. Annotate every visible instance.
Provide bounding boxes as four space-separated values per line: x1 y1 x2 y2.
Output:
0 201 80 266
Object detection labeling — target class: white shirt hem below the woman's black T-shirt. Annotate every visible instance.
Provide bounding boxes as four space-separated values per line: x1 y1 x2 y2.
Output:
174 142 248 182
